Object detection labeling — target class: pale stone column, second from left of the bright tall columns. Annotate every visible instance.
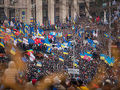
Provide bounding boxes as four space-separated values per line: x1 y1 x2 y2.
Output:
48 0 55 24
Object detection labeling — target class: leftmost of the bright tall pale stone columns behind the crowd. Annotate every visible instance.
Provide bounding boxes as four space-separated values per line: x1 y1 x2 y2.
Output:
36 0 43 25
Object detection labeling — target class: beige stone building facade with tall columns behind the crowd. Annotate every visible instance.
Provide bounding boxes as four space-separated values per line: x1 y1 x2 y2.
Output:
0 0 92 24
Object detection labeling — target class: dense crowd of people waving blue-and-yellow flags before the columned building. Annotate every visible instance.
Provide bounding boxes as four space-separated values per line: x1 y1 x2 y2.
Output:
0 14 119 90
